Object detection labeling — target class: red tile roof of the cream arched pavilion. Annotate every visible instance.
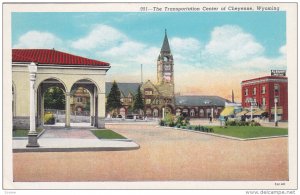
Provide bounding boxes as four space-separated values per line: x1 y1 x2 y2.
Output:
12 49 109 66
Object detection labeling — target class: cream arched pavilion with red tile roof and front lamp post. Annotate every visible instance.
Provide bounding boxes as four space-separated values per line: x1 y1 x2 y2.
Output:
12 49 110 147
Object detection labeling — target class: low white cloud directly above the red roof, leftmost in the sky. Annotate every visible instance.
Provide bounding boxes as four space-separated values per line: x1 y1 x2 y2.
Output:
13 31 62 49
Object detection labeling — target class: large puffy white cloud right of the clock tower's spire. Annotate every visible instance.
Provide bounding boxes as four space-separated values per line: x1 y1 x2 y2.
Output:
203 25 264 61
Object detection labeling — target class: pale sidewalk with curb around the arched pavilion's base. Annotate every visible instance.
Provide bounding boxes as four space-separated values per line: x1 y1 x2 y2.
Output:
13 127 140 152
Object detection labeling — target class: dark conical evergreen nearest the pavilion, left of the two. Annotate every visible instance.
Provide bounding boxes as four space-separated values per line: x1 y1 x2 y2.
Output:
106 81 122 114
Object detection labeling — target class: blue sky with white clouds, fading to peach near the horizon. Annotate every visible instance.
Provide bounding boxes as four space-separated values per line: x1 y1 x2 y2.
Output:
12 11 286 100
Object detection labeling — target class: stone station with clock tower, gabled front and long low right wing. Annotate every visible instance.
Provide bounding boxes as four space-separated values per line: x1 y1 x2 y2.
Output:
141 32 228 118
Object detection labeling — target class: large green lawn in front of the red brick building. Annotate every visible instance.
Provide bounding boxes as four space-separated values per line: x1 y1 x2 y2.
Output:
213 126 288 138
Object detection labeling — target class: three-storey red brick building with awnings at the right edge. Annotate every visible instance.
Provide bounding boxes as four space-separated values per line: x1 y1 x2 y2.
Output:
241 76 288 121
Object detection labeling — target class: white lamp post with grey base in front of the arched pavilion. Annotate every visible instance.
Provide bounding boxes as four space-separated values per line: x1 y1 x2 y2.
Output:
26 62 40 147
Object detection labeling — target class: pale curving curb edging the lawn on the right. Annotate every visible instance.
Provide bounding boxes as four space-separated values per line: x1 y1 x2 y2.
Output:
156 126 288 141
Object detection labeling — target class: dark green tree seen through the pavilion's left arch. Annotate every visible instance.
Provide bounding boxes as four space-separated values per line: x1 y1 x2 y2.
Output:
44 87 66 110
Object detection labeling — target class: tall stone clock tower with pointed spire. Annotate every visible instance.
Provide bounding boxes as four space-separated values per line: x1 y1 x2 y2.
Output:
157 30 174 96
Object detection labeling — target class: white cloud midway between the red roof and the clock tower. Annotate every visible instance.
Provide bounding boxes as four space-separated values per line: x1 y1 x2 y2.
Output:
71 24 127 50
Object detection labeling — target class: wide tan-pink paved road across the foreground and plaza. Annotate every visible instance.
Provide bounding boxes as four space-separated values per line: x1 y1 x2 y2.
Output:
13 124 288 182
